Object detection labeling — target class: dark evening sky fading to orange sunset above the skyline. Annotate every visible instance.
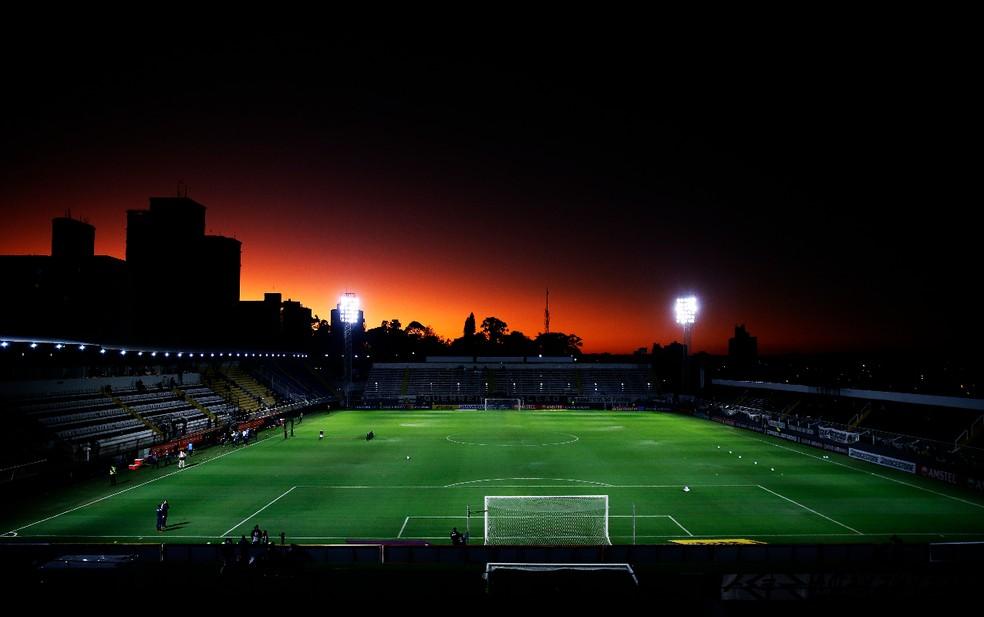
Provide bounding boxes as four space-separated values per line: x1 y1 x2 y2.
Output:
0 20 981 352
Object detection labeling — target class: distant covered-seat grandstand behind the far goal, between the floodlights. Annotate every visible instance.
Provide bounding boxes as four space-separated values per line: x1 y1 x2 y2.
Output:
363 357 657 406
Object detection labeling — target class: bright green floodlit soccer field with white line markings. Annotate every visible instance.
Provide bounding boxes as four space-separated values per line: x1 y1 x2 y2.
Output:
0 411 984 544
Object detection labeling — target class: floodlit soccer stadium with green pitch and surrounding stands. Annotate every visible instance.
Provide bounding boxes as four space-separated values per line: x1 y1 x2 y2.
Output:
0 340 984 597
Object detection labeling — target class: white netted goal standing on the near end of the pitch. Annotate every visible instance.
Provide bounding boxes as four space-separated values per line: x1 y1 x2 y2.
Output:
484 495 612 545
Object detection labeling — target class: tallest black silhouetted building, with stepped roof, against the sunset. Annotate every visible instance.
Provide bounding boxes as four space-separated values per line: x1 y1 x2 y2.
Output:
126 197 242 345
